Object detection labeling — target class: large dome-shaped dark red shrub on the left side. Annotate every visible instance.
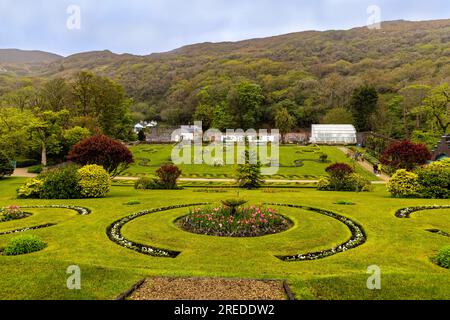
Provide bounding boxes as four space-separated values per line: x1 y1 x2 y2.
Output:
68 135 133 177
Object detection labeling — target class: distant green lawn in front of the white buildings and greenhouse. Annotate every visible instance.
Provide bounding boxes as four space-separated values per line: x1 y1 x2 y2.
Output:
123 145 378 180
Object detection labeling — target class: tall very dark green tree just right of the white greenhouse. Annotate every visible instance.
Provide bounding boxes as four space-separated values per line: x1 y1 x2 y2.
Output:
350 85 378 132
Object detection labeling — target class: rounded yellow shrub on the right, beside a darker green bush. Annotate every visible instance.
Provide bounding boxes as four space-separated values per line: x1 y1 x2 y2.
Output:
387 169 419 198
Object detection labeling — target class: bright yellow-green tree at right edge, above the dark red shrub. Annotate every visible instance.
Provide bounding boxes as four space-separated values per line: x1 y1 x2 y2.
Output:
422 83 450 134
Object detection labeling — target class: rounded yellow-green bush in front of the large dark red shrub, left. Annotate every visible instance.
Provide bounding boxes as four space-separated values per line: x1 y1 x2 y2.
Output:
77 164 111 198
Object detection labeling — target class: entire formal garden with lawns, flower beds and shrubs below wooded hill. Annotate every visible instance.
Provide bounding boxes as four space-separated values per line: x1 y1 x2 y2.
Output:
0 135 450 299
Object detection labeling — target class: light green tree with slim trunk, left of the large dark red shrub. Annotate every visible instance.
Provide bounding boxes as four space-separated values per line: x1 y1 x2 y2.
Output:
28 110 69 166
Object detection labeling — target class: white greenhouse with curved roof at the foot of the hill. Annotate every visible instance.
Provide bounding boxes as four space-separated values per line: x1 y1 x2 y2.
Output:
310 124 357 145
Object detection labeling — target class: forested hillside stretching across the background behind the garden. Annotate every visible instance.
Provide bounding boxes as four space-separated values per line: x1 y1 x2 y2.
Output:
0 20 450 159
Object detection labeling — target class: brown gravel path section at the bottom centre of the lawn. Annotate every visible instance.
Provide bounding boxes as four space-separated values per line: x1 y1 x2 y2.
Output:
130 278 287 300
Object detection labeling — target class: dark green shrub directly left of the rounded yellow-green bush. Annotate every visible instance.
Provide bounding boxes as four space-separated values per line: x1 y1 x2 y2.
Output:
38 165 81 199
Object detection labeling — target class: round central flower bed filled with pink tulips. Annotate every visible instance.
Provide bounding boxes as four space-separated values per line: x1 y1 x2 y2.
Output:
176 205 293 237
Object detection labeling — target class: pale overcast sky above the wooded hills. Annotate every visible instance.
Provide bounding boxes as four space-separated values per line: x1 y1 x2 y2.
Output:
0 0 450 56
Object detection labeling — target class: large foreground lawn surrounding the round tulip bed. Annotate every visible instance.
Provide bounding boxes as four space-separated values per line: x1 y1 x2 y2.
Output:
0 178 450 299
